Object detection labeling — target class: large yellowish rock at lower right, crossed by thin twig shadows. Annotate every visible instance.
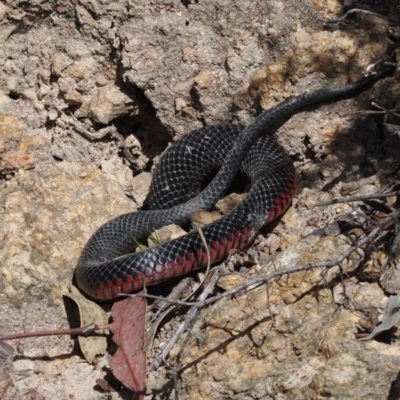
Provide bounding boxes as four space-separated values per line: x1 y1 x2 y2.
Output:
174 233 400 399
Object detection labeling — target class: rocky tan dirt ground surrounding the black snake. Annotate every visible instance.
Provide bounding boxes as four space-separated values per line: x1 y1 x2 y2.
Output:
0 0 400 400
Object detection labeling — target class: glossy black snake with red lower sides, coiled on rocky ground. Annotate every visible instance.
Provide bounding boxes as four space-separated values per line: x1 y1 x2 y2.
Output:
76 68 392 300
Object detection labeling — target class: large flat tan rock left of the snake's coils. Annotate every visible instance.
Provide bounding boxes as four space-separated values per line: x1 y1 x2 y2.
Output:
0 162 132 304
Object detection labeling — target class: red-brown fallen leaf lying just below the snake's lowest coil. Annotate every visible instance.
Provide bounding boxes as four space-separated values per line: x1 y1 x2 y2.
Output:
110 297 147 399
